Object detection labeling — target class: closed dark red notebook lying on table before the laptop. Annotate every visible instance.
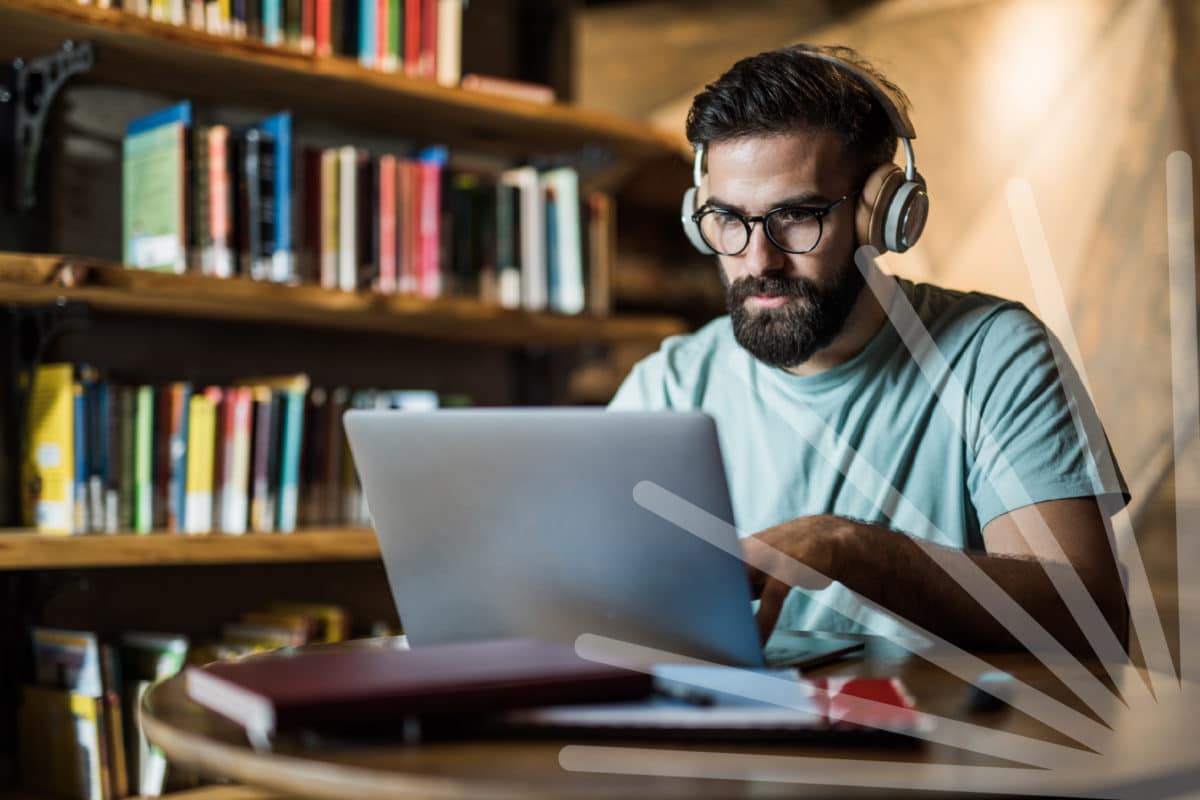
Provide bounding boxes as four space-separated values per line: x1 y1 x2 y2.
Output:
187 639 653 735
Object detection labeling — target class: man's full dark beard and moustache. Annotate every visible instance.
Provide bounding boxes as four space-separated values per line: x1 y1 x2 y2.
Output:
721 261 866 369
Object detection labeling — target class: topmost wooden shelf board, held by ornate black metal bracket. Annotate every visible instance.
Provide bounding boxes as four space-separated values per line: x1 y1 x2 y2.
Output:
0 0 685 181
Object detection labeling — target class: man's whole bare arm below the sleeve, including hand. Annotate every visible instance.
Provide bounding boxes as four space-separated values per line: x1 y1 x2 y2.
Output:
744 498 1127 652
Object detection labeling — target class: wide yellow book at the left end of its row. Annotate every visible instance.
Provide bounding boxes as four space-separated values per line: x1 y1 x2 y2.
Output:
24 363 76 534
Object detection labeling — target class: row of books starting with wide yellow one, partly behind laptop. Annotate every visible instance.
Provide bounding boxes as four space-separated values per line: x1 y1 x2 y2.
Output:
23 363 464 534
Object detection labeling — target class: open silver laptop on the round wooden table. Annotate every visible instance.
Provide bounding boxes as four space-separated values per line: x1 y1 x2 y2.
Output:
344 409 862 667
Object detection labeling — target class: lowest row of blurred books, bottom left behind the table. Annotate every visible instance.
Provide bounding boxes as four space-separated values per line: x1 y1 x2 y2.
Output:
18 602 355 800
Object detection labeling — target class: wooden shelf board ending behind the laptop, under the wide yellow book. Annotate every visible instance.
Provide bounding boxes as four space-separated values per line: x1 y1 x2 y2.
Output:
0 528 379 571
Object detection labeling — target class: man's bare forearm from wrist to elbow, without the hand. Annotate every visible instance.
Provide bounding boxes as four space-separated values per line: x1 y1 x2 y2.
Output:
826 517 1126 652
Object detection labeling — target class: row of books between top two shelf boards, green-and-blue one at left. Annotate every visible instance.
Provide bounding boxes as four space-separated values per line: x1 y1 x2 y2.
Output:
122 102 616 315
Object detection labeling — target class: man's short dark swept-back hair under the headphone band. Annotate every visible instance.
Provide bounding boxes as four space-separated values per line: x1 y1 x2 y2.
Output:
688 44 908 170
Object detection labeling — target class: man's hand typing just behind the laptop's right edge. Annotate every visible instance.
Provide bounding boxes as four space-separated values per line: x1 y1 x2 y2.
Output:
742 515 856 644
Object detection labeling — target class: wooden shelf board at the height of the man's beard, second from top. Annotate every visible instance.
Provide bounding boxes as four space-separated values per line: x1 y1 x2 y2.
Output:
0 253 684 345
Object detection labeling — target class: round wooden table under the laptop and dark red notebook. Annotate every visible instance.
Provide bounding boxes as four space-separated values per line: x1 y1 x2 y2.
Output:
143 639 1180 800
